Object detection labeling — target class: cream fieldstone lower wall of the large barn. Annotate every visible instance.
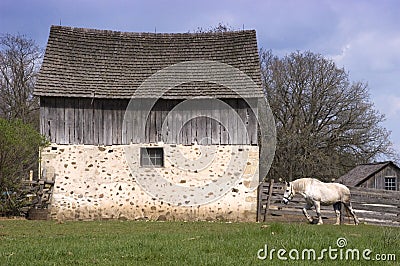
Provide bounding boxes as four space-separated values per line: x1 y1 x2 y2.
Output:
41 144 259 221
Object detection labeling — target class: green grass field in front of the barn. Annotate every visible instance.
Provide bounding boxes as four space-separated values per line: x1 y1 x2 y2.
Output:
0 220 400 265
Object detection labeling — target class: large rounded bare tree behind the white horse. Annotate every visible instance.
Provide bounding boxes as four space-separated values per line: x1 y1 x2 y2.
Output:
260 50 392 180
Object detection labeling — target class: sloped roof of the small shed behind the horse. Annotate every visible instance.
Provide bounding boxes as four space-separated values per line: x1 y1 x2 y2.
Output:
336 161 398 187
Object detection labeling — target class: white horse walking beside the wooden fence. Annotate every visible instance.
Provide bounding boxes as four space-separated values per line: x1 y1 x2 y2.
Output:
283 178 359 224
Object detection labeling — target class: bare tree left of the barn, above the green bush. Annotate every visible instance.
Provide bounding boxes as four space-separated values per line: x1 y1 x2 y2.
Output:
0 34 43 127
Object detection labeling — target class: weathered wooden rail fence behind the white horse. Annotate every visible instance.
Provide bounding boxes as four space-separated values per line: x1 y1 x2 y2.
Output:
257 181 400 226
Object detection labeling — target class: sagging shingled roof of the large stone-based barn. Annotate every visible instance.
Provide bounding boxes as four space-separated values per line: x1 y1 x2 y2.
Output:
34 26 263 99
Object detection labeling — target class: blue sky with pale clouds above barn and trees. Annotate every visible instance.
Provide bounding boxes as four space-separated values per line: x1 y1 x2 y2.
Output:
0 0 400 160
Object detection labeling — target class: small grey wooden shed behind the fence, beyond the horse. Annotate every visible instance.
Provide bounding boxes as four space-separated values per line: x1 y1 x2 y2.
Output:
337 161 400 191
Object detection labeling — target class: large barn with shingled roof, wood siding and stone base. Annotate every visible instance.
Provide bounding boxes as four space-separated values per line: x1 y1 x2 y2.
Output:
34 26 263 221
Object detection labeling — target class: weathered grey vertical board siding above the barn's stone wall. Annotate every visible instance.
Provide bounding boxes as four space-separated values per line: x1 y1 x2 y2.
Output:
40 97 257 145
